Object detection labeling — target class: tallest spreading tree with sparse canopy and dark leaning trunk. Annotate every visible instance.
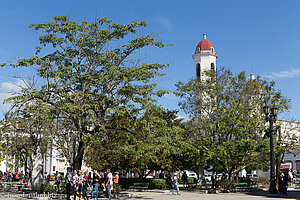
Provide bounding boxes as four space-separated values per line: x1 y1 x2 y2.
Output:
3 16 167 169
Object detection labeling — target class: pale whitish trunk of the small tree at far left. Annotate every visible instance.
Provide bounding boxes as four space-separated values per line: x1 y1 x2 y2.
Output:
31 148 43 190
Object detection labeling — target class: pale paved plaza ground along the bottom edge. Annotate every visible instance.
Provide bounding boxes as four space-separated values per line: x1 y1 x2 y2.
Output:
0 189 300 200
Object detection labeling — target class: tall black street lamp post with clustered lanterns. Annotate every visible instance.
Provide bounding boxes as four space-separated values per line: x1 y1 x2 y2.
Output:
263 105 278 194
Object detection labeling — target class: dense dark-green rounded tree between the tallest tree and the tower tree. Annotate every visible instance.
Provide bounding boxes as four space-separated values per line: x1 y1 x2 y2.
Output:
87 105 184 174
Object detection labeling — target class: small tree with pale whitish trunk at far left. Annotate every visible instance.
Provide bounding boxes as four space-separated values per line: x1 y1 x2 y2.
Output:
1 98 54 189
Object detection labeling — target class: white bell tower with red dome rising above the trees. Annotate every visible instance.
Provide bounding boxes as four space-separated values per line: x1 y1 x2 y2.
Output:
193 33 218 80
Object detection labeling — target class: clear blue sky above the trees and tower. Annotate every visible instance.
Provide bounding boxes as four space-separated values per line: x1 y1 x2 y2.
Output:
0 0 300 120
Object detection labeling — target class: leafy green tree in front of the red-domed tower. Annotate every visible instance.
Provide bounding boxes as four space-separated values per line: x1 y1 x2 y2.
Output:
176 68 289 179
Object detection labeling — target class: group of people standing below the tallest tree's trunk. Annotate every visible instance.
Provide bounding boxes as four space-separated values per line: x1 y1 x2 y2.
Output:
65 167 119 200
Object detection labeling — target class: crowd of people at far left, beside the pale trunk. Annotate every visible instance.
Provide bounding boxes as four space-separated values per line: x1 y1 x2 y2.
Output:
0 170 31 185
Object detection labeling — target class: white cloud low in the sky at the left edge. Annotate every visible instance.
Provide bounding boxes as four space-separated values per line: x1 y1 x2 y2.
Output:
0 79 26 114
